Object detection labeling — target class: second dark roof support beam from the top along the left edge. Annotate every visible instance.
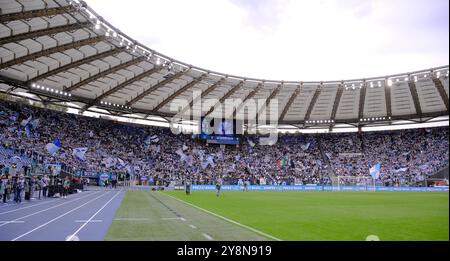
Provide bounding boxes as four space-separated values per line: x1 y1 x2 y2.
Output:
0 22 91 45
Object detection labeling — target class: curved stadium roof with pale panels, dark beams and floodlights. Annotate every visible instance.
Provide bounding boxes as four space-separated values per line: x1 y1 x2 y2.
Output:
0 0 449 128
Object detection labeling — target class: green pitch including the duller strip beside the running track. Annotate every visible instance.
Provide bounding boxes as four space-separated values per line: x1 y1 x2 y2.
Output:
106 191 449 241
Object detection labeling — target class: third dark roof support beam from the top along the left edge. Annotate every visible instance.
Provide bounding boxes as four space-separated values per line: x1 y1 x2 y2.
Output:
0 36 105 70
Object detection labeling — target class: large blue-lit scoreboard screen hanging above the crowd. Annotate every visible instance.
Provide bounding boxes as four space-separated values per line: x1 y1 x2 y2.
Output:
199 118 243 145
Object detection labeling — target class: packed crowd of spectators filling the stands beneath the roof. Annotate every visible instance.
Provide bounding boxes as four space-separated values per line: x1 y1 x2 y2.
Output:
0 97 449 186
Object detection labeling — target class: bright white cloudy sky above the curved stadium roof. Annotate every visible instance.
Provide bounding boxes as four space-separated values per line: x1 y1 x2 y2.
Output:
86 0 449 81
